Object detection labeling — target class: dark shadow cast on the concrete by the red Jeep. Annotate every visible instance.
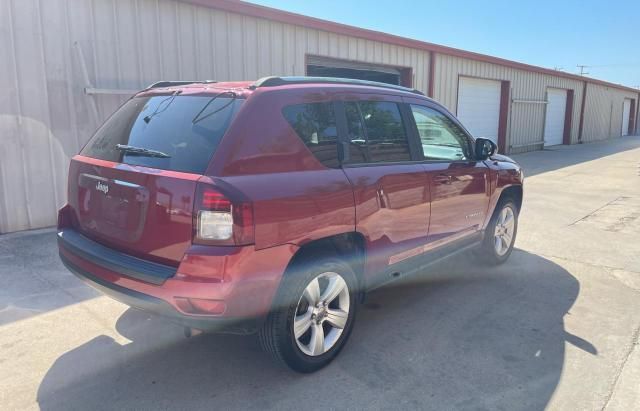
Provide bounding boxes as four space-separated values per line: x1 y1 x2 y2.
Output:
38 250 598 410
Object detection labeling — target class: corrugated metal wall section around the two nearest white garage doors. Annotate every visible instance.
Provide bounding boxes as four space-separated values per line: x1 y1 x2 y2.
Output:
434 54 583 153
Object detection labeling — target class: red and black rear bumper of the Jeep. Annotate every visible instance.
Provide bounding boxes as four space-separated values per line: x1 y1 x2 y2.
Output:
58 229 295 334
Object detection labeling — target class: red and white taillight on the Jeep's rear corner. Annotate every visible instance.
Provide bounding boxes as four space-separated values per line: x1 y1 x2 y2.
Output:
193 183 254 245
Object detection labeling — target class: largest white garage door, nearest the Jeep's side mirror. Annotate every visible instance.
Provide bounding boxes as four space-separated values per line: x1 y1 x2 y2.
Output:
457 77 501 144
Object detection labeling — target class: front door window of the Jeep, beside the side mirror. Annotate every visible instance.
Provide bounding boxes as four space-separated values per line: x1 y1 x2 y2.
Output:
411 105 470 161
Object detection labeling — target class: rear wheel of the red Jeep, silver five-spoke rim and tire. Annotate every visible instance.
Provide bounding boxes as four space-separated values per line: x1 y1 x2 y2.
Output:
259 259 357 373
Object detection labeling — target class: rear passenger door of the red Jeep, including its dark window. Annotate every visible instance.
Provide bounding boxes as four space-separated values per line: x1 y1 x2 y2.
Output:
338 94 429 282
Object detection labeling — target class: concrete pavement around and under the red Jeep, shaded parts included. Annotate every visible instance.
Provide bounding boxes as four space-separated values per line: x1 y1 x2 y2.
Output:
0 137 640 410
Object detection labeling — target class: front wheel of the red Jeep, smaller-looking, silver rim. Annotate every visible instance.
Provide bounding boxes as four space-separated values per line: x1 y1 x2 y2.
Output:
478 199 518 265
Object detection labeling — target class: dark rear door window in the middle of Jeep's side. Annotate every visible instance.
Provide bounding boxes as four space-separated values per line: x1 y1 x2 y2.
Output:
345 101 411 163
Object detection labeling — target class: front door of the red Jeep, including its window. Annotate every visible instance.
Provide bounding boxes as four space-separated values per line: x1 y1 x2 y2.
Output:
410 101 489 250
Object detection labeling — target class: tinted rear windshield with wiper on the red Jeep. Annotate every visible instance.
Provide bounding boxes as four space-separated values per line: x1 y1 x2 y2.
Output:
80 93 244 174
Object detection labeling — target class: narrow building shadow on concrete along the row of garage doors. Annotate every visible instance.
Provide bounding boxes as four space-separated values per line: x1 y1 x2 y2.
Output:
513 136 640 178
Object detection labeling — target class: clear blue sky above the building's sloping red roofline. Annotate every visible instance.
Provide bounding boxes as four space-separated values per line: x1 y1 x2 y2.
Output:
251 0 640 87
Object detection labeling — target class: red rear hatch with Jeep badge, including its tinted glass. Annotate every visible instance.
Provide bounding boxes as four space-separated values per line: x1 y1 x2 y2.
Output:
69 91 243 266
